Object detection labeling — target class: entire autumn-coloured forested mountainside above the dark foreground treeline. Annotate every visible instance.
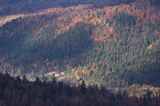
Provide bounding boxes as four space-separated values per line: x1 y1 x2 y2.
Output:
0 0 160 87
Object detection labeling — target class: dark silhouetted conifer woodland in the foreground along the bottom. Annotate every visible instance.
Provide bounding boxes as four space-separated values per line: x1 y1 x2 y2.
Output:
0 74 160 106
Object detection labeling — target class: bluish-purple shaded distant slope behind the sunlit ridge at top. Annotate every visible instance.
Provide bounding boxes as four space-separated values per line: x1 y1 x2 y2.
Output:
0 0 135 16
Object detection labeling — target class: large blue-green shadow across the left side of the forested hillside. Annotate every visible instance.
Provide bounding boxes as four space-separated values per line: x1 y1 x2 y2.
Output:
0 17 92 65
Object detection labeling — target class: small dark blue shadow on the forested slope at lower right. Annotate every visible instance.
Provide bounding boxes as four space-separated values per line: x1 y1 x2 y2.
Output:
125 63 160 86
